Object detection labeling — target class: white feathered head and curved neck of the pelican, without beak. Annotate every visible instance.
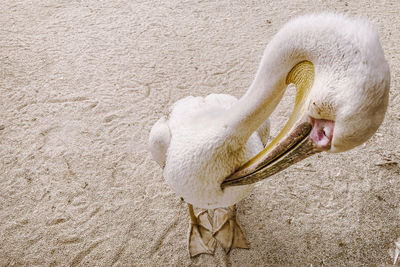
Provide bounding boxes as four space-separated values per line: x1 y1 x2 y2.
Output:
229 14 390 152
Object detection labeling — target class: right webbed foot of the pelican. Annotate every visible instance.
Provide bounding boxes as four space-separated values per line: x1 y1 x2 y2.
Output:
213 206 249 254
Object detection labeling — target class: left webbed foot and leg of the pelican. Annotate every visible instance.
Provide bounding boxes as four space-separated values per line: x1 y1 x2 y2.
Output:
188 203 217 257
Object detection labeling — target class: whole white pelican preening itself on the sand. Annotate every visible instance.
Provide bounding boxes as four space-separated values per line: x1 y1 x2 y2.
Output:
149 13 390 256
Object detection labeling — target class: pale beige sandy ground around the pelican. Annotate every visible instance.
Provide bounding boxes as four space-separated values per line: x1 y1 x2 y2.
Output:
0 0 400 266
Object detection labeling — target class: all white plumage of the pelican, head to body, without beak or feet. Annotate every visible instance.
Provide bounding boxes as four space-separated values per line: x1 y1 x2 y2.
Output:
149 14 390 208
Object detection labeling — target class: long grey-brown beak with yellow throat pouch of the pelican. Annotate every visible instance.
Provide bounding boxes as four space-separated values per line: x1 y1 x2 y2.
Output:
221 61 319 189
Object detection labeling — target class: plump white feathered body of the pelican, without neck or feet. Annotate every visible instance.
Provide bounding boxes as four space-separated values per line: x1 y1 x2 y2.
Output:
150 94 269 208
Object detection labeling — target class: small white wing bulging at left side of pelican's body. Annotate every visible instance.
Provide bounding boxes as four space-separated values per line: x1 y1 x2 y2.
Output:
149 117 171 168
